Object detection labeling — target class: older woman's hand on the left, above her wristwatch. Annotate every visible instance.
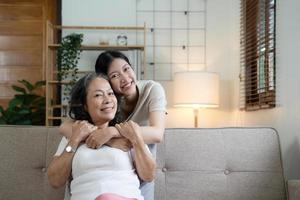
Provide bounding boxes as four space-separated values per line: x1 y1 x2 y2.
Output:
70 121 97 144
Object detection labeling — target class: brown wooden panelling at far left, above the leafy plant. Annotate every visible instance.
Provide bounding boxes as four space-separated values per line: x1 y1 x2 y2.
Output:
0 0 59 108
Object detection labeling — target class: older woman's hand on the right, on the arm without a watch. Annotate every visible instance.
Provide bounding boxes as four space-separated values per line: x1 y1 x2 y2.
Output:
115 121 143 145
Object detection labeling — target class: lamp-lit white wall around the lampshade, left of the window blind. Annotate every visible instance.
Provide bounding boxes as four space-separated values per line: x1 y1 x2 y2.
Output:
163 0 239 128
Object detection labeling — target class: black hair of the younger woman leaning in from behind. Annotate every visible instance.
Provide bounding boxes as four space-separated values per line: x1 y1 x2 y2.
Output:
95 51 131 75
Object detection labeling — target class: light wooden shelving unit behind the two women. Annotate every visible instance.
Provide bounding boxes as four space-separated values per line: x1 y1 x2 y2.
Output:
45 21 146 126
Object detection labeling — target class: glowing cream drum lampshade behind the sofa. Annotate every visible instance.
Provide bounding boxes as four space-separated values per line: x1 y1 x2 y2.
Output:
174 71 219 108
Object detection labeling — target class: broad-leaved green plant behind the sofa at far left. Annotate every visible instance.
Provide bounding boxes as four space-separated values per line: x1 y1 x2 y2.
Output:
0 80 46 125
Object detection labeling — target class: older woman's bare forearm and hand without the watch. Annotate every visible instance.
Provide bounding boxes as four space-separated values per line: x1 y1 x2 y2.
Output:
116 121 156 181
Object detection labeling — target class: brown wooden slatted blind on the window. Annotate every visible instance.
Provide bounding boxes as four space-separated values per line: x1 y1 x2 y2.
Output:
239 0 276 110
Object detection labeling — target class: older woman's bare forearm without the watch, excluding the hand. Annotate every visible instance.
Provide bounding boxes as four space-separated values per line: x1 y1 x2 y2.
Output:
132 138 156 182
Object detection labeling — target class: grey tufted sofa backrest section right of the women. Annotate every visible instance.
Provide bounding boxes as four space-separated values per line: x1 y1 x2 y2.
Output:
155 128 286 200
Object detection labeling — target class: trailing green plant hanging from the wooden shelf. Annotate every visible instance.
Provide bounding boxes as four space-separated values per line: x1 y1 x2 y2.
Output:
57 33 83 100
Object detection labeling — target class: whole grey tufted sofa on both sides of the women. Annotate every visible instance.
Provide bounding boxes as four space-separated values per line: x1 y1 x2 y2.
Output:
0 126 300 200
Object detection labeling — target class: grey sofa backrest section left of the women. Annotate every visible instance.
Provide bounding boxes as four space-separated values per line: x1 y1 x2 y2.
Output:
0 126 64 200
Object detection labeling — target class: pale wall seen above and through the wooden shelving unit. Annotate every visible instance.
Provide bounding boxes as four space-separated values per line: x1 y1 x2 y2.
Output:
62 0 137 104
